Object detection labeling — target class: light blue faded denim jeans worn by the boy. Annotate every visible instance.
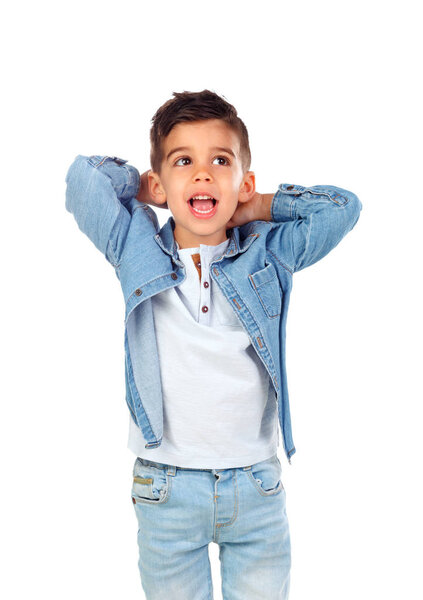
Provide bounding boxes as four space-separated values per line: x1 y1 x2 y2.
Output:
132 454 291 600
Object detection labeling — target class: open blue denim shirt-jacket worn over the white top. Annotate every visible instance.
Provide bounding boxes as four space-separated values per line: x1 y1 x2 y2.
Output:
66 155 362 462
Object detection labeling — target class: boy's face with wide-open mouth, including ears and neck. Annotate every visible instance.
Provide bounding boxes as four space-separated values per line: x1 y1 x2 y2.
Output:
149 119 255 248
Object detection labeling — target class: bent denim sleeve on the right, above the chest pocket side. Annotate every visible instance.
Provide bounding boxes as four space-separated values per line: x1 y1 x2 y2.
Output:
268 183 362 272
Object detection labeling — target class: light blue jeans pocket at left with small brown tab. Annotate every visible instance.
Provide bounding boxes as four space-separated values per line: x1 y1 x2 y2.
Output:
131 457 171 504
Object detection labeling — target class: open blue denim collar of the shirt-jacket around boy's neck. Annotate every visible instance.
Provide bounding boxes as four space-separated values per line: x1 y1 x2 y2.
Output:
154 216 260 261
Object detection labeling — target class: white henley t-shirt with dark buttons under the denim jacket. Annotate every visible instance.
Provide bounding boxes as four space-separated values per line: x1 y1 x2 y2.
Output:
128 239 279 469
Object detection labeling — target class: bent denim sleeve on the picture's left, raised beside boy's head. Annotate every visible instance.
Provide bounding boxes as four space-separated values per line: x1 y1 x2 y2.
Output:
65 154 140 267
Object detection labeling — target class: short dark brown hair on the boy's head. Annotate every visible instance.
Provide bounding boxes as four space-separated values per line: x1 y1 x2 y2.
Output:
150 90 251 174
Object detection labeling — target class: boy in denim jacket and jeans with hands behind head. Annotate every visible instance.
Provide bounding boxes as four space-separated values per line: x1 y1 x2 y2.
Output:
66 90 361 600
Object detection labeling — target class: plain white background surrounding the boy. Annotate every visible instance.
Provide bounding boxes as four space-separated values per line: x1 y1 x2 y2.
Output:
0 0 423 600
